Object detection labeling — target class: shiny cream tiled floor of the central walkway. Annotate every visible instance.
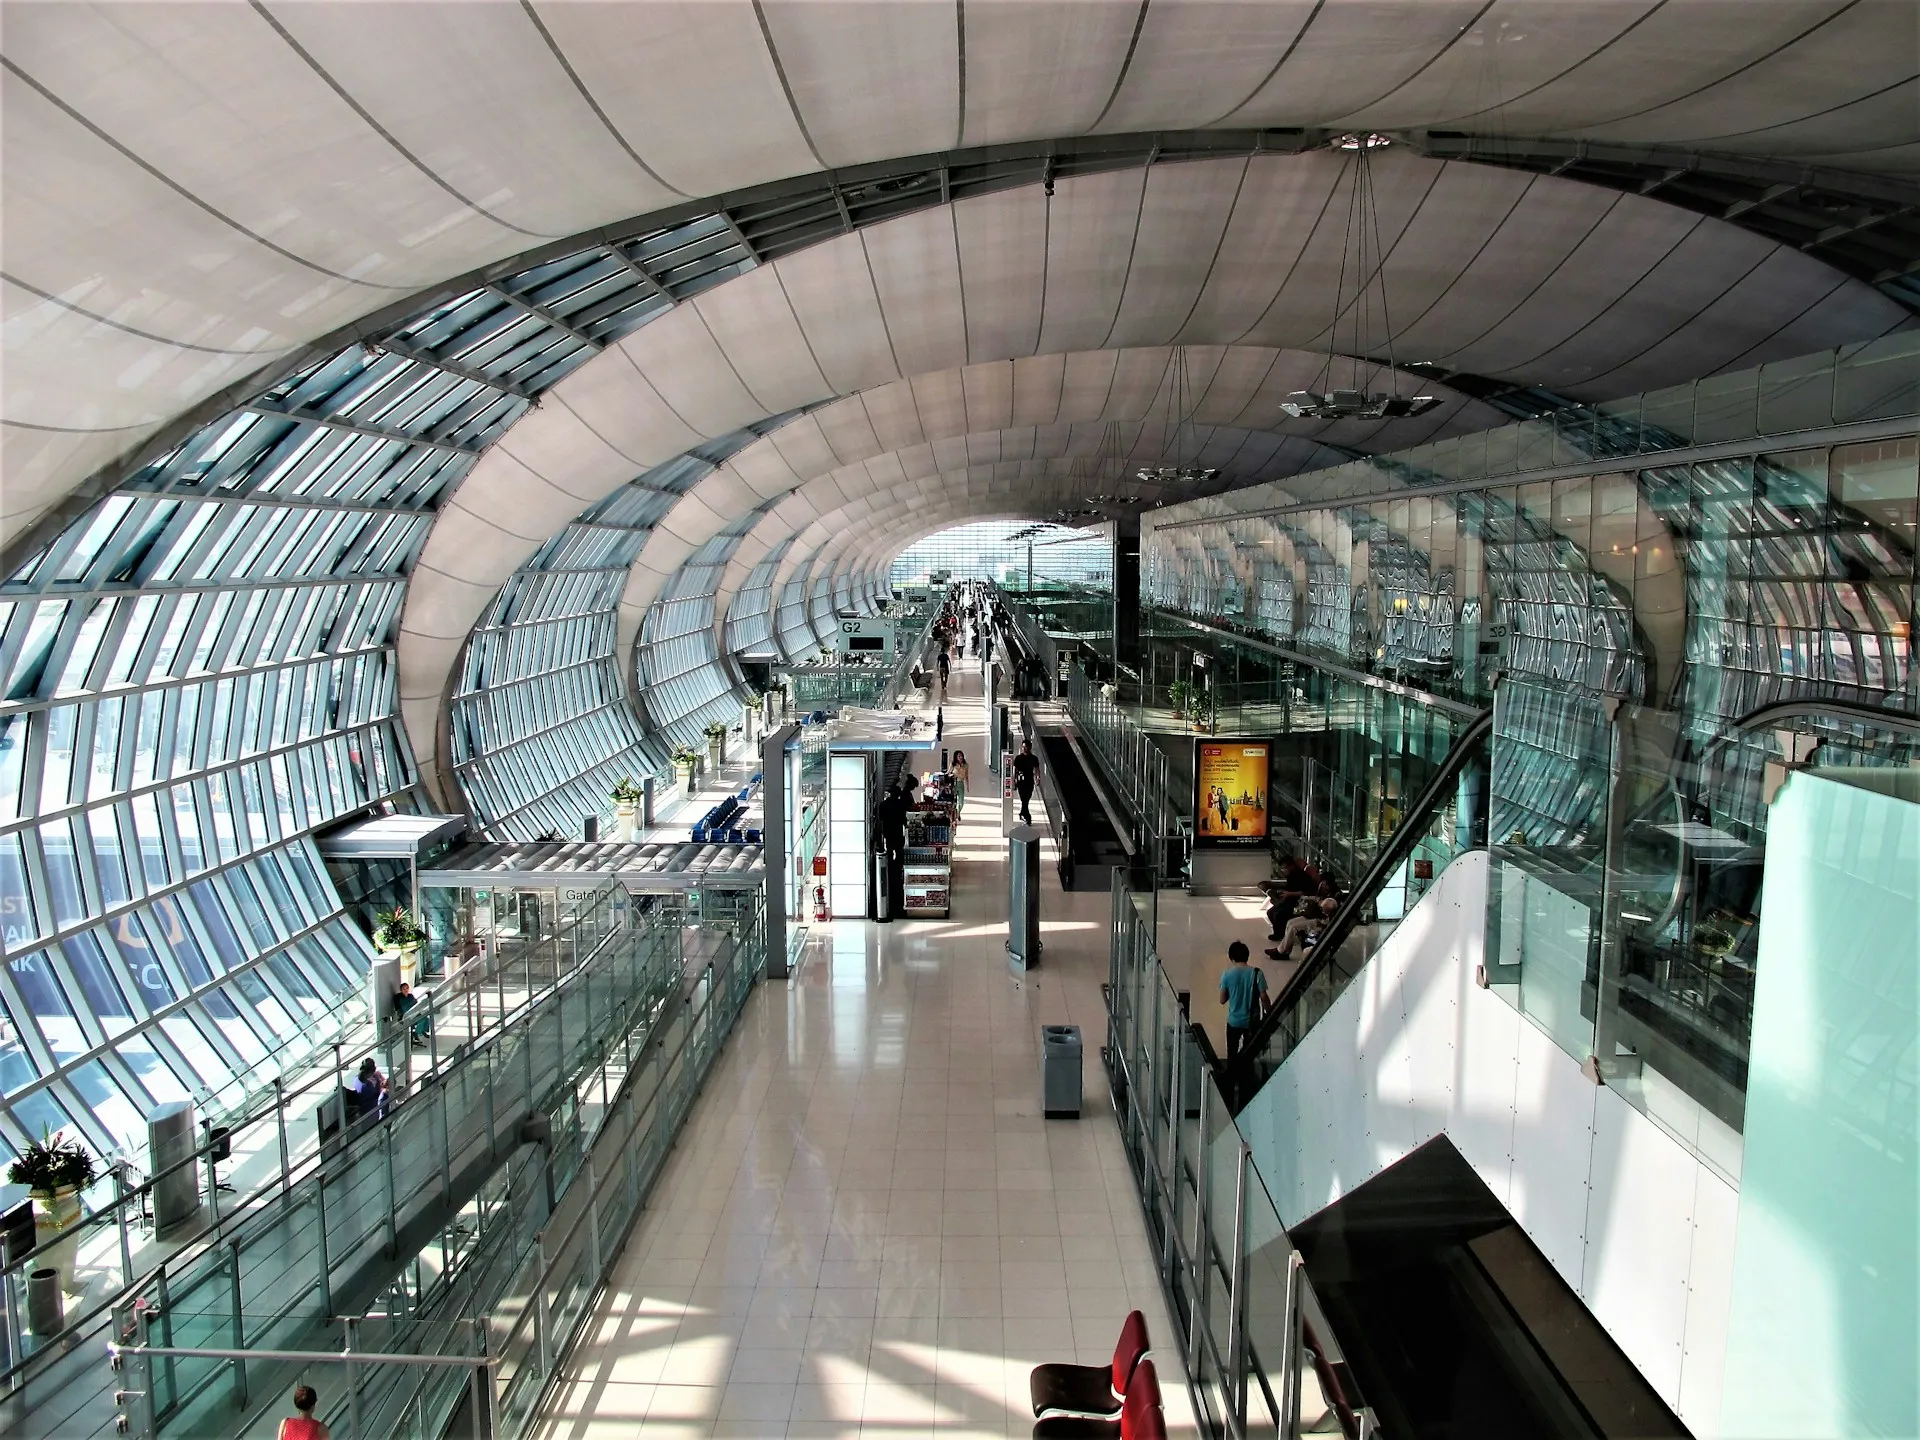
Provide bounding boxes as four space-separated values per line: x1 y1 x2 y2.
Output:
543 664 1194 1440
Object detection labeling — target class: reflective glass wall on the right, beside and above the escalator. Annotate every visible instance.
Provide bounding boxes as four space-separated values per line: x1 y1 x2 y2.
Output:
1148 355 1920 1173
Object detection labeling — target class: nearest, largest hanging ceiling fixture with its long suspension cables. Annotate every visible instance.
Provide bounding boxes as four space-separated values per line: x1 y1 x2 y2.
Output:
1281 134 1440 420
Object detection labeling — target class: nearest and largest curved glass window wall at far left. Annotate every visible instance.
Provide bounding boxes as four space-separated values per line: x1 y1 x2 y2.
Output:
0 200 802 1154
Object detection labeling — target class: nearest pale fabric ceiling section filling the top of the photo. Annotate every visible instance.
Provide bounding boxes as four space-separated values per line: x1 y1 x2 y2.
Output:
0 0 1920 528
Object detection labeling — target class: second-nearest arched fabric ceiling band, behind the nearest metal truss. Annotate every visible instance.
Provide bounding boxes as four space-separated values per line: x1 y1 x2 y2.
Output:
399 150 1908 783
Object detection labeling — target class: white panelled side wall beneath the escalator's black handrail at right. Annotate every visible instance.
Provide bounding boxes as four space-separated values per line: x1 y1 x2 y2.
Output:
1240 852 1738 1434
